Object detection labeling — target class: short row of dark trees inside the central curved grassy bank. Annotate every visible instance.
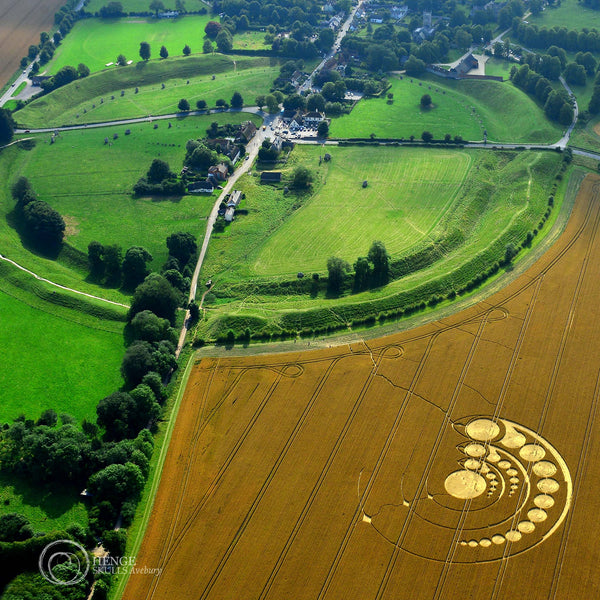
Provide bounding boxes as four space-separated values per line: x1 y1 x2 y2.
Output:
327 241 390 296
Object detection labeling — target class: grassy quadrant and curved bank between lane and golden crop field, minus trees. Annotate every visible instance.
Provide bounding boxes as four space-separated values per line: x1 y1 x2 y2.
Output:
197 147 561 339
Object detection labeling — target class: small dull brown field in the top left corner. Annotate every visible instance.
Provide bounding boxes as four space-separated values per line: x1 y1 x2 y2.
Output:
0 0 64 87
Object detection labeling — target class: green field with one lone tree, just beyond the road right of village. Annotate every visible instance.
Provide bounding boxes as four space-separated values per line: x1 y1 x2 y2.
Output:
330 76 561 143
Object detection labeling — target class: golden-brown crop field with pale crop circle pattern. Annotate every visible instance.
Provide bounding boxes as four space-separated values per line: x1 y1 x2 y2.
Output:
124 176 600 600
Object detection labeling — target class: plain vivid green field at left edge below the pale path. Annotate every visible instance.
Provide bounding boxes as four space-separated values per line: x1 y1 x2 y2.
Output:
0 281 124 423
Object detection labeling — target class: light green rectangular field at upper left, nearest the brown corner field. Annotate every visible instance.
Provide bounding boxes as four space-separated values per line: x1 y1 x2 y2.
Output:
46 15 210 74
